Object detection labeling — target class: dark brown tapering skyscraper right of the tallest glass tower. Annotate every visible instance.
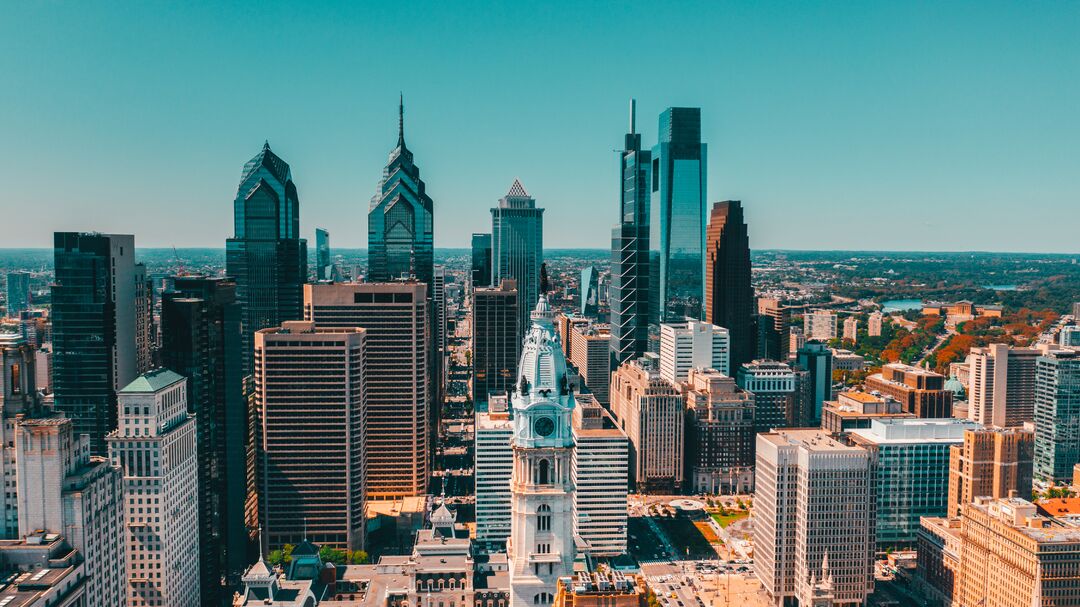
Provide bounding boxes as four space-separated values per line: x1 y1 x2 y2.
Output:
704 200 757 367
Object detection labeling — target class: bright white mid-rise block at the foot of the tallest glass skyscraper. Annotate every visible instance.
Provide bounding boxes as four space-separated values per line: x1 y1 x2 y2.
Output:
660 321 731 386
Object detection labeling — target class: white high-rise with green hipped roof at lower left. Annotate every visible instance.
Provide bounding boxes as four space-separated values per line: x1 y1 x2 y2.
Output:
107 369 199 607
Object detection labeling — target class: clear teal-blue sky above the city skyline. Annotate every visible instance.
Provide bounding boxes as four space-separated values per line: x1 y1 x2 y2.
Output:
0 1 1080 252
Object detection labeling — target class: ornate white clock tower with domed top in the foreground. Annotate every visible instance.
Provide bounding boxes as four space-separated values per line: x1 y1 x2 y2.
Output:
507 295 576 607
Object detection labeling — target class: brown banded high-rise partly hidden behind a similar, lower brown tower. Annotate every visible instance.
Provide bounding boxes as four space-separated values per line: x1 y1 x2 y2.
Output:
303 281 435 499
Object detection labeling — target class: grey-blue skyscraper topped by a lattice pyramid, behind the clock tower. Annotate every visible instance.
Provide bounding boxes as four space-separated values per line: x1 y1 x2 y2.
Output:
491 179 543 331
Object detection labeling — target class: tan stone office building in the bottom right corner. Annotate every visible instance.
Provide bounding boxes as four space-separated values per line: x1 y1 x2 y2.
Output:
954 498 1080 607
